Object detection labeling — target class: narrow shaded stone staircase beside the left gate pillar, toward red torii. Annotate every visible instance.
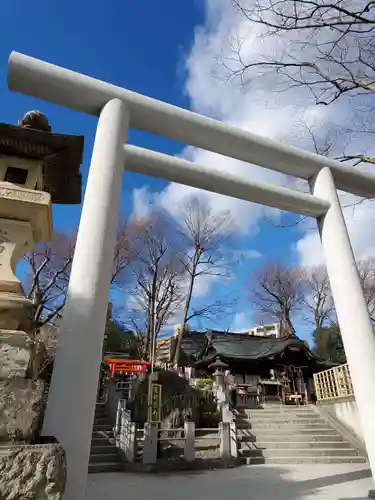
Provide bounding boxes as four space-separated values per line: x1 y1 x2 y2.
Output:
88 403 122 473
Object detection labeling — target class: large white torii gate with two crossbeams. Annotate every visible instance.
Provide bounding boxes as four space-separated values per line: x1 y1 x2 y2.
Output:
8 52 375 500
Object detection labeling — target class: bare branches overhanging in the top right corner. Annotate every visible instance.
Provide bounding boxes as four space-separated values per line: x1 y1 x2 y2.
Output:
231 0 375 105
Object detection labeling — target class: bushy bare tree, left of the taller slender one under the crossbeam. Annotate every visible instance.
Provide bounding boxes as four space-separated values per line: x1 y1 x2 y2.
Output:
129 214 183 357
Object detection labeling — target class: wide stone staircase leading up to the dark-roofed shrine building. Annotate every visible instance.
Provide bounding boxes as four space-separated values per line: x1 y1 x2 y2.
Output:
236 404 367 464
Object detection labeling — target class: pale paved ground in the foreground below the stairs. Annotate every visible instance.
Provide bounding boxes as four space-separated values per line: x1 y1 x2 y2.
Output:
86 464 373 500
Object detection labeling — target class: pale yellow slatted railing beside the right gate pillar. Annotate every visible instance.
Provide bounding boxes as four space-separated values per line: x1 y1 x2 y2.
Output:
314 363 354 401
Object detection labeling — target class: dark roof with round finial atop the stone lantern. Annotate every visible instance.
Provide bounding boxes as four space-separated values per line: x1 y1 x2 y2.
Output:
0 111 84 205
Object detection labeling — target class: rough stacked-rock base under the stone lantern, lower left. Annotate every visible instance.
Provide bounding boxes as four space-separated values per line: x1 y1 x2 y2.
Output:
0 328 66 500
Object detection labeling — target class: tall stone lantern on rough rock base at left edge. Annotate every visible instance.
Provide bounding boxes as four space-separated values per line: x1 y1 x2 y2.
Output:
0 111 83 500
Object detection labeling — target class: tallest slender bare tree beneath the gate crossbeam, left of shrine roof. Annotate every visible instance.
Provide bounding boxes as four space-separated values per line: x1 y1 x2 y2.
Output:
173 196 234 364
